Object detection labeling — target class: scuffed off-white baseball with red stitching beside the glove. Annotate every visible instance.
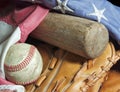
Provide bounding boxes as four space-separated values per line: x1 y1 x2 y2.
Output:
4 43 43 85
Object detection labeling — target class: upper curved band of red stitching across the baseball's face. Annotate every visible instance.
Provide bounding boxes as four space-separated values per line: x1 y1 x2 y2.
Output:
4 46 35 72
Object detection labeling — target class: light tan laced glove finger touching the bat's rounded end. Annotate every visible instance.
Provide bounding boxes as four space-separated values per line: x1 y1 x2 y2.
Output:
66 43 116 92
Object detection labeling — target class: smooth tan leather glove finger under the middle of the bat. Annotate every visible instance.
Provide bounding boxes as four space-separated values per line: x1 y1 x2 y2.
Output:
36 43 86 92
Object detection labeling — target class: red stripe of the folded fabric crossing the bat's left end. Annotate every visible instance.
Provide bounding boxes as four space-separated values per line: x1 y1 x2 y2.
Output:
0 5 48 42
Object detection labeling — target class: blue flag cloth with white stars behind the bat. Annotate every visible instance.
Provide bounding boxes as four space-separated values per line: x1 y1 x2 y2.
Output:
38 0 120 45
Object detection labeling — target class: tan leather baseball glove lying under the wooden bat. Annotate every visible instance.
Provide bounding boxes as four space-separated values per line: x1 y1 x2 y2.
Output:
25 42 120 92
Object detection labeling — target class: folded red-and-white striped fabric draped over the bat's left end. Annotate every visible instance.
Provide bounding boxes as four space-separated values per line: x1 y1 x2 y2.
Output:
0 5 48 79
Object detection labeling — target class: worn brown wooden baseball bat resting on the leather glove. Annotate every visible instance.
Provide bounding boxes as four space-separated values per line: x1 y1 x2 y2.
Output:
30 12 109 59
